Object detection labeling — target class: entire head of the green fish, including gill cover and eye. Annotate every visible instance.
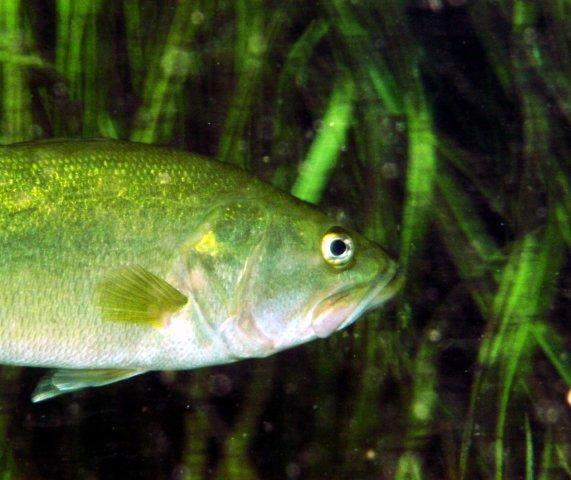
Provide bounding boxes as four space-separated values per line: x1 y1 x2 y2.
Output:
181 197 401 358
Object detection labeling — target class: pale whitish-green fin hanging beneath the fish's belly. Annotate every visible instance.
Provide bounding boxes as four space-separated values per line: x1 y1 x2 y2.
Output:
32 370 145 403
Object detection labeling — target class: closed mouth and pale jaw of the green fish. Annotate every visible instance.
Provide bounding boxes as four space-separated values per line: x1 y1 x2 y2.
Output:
311 264 403 338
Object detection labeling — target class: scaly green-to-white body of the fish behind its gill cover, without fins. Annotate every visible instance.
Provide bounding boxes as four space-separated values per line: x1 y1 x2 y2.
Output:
0 142 246 368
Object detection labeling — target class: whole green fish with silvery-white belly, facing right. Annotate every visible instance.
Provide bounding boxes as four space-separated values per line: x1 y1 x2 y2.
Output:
0 139 402 402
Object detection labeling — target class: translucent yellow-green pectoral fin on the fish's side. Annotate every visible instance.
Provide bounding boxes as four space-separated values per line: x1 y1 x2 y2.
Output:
97 266 188 327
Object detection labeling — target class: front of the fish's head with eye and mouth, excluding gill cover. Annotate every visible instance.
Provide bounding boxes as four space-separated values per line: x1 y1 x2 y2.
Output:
231 202 402 353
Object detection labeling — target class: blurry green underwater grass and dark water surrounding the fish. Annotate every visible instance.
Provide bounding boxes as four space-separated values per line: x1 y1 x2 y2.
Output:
0 0 571 479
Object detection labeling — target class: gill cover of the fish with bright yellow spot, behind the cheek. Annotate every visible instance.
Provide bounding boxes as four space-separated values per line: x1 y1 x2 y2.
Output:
177 201 274 352
